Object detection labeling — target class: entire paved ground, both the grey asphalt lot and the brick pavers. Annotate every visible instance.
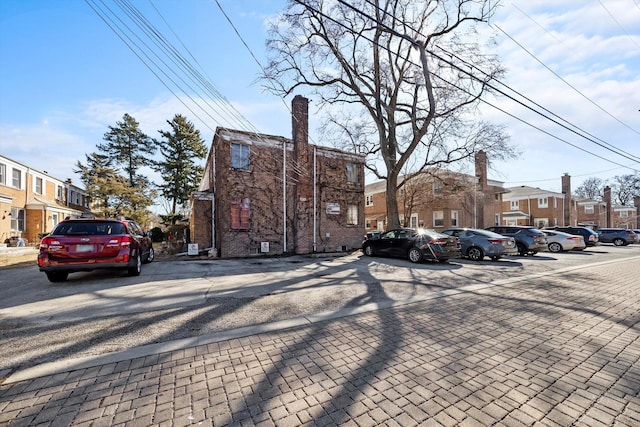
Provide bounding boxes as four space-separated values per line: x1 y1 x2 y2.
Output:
0 242 640 426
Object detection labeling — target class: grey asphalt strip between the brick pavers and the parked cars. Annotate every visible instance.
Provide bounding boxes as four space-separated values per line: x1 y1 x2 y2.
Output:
0 245 640 373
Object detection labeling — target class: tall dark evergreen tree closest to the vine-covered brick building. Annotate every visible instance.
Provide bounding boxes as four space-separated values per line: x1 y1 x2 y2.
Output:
155 114 207 216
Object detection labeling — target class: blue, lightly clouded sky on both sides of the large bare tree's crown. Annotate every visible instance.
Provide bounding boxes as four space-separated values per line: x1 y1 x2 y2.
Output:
0 0 640 202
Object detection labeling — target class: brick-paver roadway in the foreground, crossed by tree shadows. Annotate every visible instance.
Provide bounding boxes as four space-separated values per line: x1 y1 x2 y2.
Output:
0 257 640 426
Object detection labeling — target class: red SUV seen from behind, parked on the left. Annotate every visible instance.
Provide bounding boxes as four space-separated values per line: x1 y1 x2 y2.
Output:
38 219 155 282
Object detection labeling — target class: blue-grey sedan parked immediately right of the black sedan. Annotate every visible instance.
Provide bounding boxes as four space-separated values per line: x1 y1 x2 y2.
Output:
443 228 518 261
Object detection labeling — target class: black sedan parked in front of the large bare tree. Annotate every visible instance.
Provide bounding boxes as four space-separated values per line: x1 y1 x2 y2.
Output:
362 228 460 262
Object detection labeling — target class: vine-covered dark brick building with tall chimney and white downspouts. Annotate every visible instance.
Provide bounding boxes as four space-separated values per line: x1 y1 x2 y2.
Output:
190 96 365 258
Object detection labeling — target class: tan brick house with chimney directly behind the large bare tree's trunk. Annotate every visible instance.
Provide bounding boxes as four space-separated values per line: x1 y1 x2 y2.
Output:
365 151 505 232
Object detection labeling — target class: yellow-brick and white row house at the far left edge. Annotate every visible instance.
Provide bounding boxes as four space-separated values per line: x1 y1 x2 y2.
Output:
0 155 90 244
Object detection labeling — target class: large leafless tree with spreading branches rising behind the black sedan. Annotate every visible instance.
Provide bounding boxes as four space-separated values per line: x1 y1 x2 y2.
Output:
265 0 513 228
